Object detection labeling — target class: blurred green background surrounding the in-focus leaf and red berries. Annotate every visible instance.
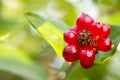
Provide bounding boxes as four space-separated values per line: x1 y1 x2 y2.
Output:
0 0 120 80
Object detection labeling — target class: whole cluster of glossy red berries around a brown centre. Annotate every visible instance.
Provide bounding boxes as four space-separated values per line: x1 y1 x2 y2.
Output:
63 13 112 68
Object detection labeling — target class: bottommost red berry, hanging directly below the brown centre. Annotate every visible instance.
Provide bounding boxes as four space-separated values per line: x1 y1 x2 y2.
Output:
79 46 96 69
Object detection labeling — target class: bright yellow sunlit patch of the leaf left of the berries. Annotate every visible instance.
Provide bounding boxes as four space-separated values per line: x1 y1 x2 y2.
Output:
38 22 65 57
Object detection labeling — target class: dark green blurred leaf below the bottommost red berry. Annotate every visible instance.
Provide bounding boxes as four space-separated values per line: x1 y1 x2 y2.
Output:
64 61 108 80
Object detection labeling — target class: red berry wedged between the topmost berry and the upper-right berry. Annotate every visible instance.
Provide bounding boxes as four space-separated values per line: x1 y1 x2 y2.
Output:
89 22 102 38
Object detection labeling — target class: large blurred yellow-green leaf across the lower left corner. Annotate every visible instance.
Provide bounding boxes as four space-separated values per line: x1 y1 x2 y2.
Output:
0 44 47 80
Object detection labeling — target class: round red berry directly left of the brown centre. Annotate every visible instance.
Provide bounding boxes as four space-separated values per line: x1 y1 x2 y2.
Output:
64 30 77 44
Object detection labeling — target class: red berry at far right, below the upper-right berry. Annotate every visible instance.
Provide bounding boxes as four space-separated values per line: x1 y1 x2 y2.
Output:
97 38 112 52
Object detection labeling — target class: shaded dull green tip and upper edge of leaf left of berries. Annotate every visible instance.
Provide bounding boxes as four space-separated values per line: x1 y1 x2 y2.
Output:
25 12 69 31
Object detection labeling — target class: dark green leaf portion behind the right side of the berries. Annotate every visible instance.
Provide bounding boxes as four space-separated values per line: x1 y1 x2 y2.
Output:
95 25 120 64
